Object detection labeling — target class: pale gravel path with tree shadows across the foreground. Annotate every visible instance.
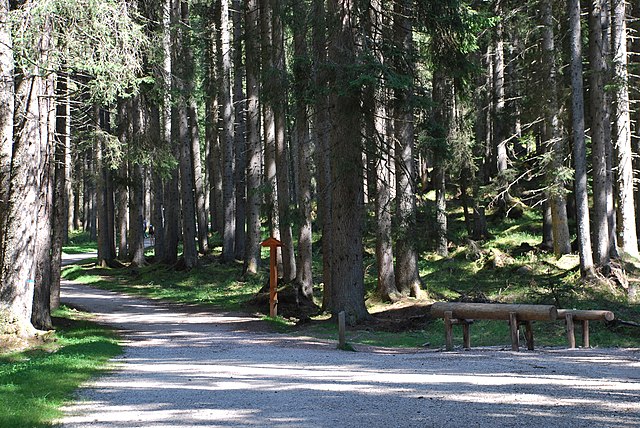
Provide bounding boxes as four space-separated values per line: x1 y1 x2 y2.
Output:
56 282 640 428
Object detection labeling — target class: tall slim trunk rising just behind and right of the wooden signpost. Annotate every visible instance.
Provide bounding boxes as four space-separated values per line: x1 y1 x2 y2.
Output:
271 0 296 283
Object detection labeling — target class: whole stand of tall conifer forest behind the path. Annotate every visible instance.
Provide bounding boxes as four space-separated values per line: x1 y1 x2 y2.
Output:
0 0 640 335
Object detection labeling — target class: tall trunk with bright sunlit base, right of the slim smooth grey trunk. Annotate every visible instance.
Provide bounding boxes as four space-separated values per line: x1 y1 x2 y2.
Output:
589 0 610 267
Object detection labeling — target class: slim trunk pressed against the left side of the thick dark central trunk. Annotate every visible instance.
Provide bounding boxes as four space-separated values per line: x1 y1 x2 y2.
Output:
312 0 332 310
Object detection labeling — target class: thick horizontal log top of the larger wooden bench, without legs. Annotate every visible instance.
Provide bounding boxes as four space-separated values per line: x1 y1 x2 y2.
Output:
431 302 557 321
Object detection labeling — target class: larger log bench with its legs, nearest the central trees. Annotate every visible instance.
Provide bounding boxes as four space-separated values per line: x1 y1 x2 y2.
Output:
431 302 558 351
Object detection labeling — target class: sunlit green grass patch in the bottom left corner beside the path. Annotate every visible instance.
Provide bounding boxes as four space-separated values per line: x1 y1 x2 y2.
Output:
0 308 121 428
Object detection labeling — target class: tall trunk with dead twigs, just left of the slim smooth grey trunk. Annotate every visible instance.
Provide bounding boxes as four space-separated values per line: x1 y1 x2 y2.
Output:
542 0 571 256
